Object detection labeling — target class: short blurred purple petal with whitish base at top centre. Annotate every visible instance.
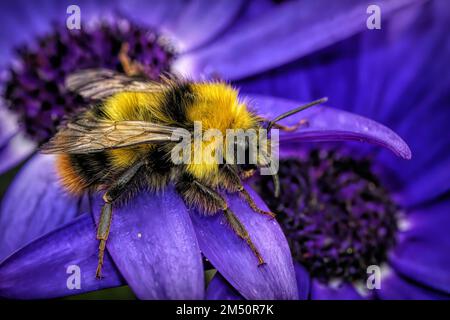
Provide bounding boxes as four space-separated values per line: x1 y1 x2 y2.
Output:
164 0 244 51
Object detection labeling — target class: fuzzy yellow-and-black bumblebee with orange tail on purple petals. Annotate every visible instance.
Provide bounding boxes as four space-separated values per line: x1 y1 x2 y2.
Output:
41 58 325 278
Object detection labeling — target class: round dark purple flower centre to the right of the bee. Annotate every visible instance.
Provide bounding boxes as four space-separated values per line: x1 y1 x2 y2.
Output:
254 150 399 282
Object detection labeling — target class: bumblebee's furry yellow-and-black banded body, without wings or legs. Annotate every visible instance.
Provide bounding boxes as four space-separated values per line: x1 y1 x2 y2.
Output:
58 81 257 201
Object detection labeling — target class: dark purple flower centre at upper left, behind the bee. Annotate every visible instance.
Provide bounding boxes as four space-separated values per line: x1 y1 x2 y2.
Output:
3 19 175 143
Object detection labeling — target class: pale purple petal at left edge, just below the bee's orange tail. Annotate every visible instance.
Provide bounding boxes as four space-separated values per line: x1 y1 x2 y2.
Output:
0 155 79 260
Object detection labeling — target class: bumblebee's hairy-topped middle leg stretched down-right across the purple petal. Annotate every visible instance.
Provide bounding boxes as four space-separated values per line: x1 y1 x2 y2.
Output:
176 174 264 265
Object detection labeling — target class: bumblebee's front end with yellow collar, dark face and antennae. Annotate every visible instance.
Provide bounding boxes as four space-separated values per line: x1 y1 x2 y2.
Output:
186 82 327 198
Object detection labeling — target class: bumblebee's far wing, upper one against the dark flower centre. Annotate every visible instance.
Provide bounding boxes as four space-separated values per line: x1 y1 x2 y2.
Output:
65 69 165 100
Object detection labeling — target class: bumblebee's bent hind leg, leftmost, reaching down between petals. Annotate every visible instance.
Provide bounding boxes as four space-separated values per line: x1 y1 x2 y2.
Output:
95 162 143 279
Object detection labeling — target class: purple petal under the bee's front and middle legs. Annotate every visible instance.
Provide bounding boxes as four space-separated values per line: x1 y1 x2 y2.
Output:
191 188 298 300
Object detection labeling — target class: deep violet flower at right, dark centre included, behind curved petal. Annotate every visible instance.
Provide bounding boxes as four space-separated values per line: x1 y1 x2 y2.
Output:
207 1 450 299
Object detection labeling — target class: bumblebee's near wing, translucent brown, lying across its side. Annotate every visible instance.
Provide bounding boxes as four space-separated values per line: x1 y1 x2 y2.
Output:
41 119 183 154
